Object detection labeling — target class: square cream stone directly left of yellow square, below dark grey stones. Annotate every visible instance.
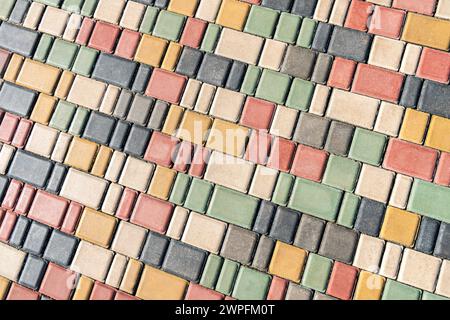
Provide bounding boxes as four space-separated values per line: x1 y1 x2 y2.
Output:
119 157 155 192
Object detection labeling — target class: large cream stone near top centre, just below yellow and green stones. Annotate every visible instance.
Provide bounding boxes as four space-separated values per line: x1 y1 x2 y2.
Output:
216 28 264 65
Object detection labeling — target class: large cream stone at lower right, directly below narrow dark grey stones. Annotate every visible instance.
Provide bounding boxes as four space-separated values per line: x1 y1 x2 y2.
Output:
398 249 441 292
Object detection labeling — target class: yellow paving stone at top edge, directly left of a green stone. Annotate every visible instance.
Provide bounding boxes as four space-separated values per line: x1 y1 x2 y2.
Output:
216 0 250 30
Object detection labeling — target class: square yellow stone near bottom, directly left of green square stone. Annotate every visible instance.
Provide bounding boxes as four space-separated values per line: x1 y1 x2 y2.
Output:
269 241 306 282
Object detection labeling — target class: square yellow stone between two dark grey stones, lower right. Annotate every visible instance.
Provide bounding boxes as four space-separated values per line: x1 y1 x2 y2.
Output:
380 207 420 247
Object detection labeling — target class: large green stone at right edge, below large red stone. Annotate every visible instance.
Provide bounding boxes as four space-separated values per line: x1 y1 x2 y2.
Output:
408 179 450 223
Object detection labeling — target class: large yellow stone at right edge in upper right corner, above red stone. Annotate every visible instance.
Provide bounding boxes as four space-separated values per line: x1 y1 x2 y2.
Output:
402 12 450 50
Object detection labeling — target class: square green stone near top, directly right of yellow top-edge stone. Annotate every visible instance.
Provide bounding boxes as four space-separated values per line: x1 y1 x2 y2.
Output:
244 6 278 38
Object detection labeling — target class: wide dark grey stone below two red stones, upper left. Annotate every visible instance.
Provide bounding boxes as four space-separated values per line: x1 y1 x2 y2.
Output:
92 52 138 89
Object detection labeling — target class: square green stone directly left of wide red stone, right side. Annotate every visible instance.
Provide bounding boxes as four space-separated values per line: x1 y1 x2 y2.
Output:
348 128 387 166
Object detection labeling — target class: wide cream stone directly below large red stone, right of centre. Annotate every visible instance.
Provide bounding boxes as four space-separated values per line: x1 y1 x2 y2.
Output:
326 89 380 129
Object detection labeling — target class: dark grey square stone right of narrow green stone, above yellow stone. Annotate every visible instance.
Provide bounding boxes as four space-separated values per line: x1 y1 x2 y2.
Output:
83 112 116 145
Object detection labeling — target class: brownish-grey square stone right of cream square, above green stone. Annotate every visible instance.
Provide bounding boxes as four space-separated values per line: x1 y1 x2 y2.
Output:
281 46 316 80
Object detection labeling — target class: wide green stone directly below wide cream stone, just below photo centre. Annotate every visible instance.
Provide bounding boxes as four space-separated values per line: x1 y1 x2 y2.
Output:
207 186 259 229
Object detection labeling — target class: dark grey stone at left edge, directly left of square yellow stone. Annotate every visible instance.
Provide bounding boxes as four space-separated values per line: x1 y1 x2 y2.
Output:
0 82 37 117
